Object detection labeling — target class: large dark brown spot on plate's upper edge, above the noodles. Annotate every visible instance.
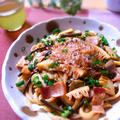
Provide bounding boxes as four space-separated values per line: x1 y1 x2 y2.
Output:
46 20 59 33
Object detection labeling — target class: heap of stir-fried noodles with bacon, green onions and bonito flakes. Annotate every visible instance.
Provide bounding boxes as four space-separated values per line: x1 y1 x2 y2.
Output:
16 29 120 120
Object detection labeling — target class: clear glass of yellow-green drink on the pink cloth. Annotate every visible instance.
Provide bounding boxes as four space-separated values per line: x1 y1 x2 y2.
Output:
0 1 26 30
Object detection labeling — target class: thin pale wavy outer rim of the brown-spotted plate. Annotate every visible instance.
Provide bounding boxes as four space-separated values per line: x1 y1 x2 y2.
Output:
1 16 120 120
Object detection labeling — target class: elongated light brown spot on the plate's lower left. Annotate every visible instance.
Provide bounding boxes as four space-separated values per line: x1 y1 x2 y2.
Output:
21 106 38 117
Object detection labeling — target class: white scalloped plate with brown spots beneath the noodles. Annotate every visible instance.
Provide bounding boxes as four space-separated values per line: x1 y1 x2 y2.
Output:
2 17 120 120
